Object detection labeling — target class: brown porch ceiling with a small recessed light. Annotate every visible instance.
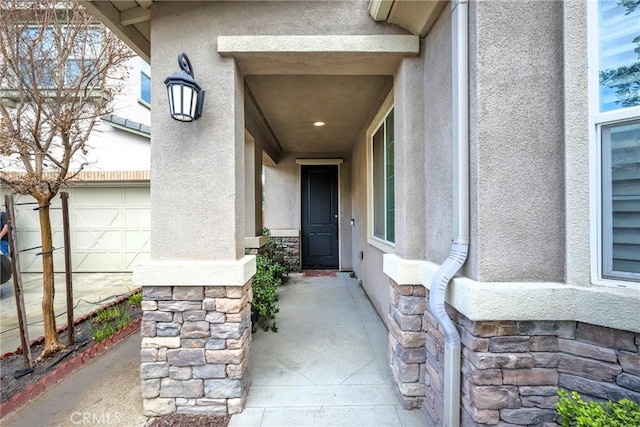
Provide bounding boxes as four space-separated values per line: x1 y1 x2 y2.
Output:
246 74 392 154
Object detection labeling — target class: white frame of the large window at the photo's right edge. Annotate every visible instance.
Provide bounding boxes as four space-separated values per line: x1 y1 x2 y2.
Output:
587 1 640 289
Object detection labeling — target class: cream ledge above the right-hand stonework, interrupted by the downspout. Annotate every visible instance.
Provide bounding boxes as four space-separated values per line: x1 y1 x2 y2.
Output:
383 254 640 332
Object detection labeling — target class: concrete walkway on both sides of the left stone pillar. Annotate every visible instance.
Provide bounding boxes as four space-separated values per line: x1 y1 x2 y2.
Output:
1 273 427 427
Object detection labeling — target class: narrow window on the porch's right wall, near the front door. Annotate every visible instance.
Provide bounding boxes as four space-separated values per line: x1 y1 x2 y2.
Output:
368 93 395 250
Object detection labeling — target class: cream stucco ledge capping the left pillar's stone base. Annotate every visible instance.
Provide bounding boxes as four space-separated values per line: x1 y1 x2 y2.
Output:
133 255 256 286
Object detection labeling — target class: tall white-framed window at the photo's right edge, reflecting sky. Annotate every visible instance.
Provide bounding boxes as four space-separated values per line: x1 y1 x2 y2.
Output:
590 0 640 282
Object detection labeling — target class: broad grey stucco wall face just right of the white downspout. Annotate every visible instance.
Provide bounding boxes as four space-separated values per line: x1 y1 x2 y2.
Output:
469 1 565 282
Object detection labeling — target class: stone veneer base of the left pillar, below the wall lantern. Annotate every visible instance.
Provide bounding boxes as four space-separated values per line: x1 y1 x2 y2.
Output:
140 281 251 417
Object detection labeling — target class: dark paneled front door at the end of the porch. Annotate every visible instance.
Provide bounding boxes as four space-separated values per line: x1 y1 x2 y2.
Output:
302 165 338 268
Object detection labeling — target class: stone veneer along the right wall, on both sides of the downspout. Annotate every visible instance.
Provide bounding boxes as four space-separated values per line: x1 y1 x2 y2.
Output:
389 281 640 426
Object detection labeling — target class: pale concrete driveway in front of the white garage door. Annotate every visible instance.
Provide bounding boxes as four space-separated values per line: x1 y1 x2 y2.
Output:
0 273 135 357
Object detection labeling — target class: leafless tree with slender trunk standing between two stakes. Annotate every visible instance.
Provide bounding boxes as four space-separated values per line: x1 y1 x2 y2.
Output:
0 0 133 357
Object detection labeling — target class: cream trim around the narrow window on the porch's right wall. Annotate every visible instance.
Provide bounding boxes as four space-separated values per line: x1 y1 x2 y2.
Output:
366 91 396 254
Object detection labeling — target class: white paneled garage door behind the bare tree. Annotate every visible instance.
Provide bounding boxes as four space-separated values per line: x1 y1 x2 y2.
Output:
15 187 150 272
